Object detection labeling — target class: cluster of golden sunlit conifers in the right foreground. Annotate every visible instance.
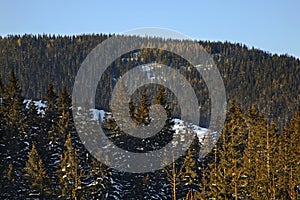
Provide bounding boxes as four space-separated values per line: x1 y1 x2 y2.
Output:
200 102 300 199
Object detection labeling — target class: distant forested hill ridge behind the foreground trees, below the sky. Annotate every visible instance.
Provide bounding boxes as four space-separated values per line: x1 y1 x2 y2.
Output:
0 34 300 129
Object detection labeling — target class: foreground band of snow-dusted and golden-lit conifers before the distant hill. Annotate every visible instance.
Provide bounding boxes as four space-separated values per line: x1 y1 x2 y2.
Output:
0 73 300 200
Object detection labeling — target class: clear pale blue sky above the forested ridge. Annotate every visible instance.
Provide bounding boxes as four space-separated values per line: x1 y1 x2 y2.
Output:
0 0 300 58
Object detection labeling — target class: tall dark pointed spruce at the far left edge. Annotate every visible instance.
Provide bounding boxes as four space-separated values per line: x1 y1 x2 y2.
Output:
1 71 29 196
